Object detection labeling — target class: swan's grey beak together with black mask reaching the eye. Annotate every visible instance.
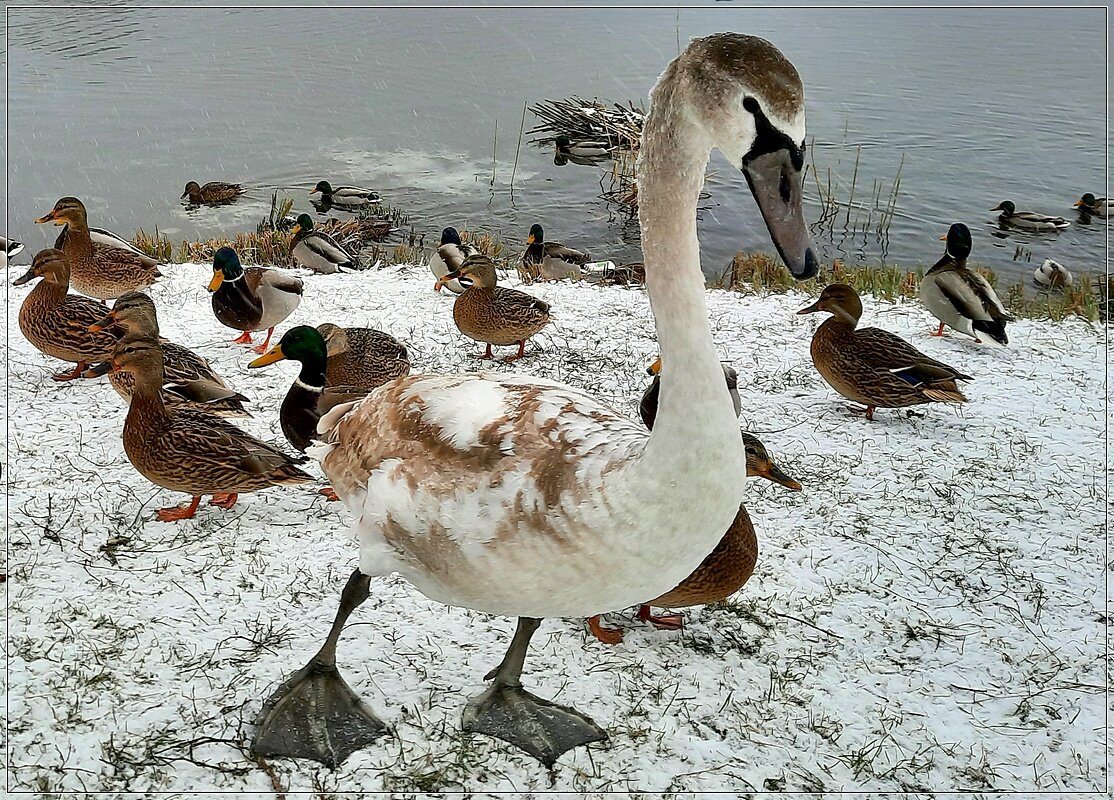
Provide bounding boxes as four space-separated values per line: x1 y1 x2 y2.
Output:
740 97 820 281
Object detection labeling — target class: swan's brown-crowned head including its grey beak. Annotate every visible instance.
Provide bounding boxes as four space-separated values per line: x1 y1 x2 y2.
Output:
663 33 820 281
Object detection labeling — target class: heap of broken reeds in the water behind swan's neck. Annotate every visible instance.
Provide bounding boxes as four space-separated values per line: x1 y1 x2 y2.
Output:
526 97 646 150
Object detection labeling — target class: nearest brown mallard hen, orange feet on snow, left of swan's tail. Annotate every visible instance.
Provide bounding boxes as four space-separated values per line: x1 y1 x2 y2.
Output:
106 336 313 523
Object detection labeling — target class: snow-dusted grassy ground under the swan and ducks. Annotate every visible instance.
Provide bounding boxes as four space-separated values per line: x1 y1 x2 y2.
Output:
4 265 1110 794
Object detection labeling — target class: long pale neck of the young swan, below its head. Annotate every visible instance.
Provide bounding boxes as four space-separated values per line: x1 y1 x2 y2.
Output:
638 86 744 475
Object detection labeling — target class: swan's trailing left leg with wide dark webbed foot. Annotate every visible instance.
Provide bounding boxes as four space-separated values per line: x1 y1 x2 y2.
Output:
252 569 387 767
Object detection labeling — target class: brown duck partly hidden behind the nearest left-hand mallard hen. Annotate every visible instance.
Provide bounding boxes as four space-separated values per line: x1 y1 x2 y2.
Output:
84 292 251 417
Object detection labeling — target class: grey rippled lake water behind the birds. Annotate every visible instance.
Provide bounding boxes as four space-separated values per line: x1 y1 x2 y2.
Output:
4 6 1107 284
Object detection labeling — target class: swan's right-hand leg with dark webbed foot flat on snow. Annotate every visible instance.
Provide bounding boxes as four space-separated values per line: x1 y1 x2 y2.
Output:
463 616 607 767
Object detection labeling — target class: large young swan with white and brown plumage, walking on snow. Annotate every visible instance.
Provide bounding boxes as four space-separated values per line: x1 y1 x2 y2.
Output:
251 33 818 768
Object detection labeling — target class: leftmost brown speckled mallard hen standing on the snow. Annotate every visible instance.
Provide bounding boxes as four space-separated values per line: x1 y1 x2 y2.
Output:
12 250 116 381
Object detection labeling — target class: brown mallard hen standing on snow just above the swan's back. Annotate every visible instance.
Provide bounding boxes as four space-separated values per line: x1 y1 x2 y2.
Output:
433 254 549 361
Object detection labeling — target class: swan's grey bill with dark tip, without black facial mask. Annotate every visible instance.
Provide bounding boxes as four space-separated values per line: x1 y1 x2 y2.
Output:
742 149 820 281
